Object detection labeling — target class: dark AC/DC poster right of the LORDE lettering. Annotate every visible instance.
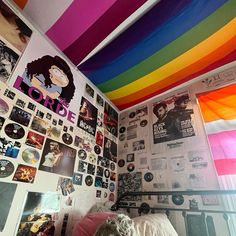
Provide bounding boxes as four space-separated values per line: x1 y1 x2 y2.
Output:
77 97 98 136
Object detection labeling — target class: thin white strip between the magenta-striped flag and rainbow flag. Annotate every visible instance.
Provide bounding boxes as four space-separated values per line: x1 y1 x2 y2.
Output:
77 0 161 66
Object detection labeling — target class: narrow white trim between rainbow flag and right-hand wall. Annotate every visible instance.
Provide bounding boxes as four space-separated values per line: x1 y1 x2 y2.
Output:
119 61 236 114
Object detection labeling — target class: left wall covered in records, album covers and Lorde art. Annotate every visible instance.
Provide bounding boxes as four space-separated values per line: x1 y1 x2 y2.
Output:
0 2 118 235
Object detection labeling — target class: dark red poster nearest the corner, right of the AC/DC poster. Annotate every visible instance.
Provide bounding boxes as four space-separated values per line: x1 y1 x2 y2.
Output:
104 102 118 137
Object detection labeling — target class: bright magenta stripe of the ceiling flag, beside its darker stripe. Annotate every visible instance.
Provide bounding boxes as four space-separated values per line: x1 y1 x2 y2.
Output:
46 0 117 50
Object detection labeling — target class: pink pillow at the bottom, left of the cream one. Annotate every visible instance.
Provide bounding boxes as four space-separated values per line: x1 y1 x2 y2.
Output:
72 212 116 236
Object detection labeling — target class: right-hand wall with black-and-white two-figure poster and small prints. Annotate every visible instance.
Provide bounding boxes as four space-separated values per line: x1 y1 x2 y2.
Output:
118 87 219 210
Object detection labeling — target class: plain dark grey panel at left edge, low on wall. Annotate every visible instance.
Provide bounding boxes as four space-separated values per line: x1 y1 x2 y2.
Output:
0 182 17 232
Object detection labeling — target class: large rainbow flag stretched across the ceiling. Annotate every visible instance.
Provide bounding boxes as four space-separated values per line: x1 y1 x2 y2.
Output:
78 0 236 110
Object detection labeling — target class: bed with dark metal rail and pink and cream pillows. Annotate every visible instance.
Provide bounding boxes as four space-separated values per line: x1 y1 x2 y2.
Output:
72 190 236 236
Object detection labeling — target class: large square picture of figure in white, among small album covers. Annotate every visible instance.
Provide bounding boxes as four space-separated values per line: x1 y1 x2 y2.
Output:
39 139 76 177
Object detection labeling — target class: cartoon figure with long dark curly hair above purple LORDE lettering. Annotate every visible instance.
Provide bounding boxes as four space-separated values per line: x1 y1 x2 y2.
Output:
13 55 75 122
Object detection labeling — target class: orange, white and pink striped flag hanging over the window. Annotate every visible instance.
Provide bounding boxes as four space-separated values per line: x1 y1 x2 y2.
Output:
198 84 236 176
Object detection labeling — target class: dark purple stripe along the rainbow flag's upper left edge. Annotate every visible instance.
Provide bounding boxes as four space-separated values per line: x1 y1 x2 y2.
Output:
78 0 191 71
